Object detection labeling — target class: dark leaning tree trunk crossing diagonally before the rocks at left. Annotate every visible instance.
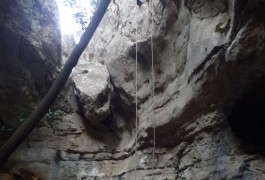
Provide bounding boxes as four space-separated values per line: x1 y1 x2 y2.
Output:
0 0 111 166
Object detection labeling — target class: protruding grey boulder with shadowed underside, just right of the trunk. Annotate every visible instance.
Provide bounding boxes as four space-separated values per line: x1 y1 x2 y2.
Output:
73 63 112 124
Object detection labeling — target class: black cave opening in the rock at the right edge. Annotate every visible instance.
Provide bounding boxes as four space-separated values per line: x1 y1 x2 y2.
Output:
229 78 265 149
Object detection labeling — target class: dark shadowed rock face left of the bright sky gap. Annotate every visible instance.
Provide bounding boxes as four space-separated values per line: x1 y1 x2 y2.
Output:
0 0 61 128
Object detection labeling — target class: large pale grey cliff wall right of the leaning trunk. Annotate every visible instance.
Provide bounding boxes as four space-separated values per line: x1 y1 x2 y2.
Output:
2 0 265 180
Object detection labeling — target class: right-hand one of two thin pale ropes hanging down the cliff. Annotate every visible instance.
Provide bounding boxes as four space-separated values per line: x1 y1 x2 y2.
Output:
151 0 156 179
